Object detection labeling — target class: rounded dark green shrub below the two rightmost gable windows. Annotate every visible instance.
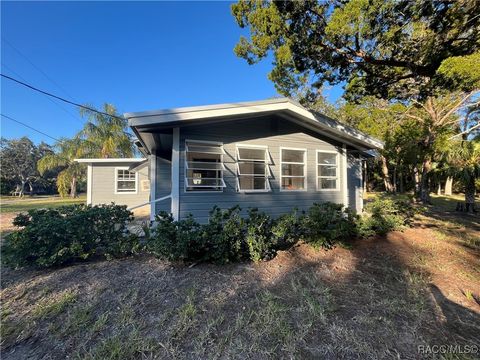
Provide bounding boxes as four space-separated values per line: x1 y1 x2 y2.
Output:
303 202 356 249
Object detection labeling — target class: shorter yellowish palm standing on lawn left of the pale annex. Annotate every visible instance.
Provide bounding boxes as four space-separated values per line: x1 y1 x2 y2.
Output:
37 138 85 198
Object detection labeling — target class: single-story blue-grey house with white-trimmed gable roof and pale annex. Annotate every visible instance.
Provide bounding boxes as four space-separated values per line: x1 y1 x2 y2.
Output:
78 98 383 222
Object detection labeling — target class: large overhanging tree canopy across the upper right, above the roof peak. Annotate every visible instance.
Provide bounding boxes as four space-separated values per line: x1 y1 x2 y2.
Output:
232 0 480 99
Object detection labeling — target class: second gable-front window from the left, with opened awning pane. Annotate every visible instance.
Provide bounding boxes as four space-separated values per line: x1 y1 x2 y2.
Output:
237 145 270 191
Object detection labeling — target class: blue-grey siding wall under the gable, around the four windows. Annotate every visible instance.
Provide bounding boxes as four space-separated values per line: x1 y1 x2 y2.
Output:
166 118 359 222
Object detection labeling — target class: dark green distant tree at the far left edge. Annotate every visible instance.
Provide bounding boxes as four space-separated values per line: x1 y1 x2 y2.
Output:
0 136 42 197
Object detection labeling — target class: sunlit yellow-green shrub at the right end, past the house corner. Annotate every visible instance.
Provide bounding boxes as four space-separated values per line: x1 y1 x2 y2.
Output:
357 198 415 237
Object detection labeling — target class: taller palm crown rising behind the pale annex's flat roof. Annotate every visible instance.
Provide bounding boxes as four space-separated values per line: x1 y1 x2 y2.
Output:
77 104 135 158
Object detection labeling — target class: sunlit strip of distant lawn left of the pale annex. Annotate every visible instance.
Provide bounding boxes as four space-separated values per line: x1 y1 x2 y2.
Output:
0 195 86 214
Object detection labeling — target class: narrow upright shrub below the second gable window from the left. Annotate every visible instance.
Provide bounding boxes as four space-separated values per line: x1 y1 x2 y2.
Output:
245 208 277 261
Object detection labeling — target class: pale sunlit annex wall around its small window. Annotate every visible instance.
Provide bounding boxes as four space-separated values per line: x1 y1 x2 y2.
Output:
89 163 150 207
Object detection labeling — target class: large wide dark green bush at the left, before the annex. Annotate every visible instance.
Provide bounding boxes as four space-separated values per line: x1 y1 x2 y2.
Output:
2 204 140 267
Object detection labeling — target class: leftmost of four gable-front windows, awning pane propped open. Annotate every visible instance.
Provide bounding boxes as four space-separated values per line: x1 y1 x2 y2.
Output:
185 140 225 191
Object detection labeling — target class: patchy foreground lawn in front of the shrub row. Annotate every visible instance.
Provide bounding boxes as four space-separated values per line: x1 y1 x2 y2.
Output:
0 195 480 359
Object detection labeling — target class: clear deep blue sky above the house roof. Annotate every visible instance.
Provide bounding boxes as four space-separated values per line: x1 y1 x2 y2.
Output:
1 1 342 144
